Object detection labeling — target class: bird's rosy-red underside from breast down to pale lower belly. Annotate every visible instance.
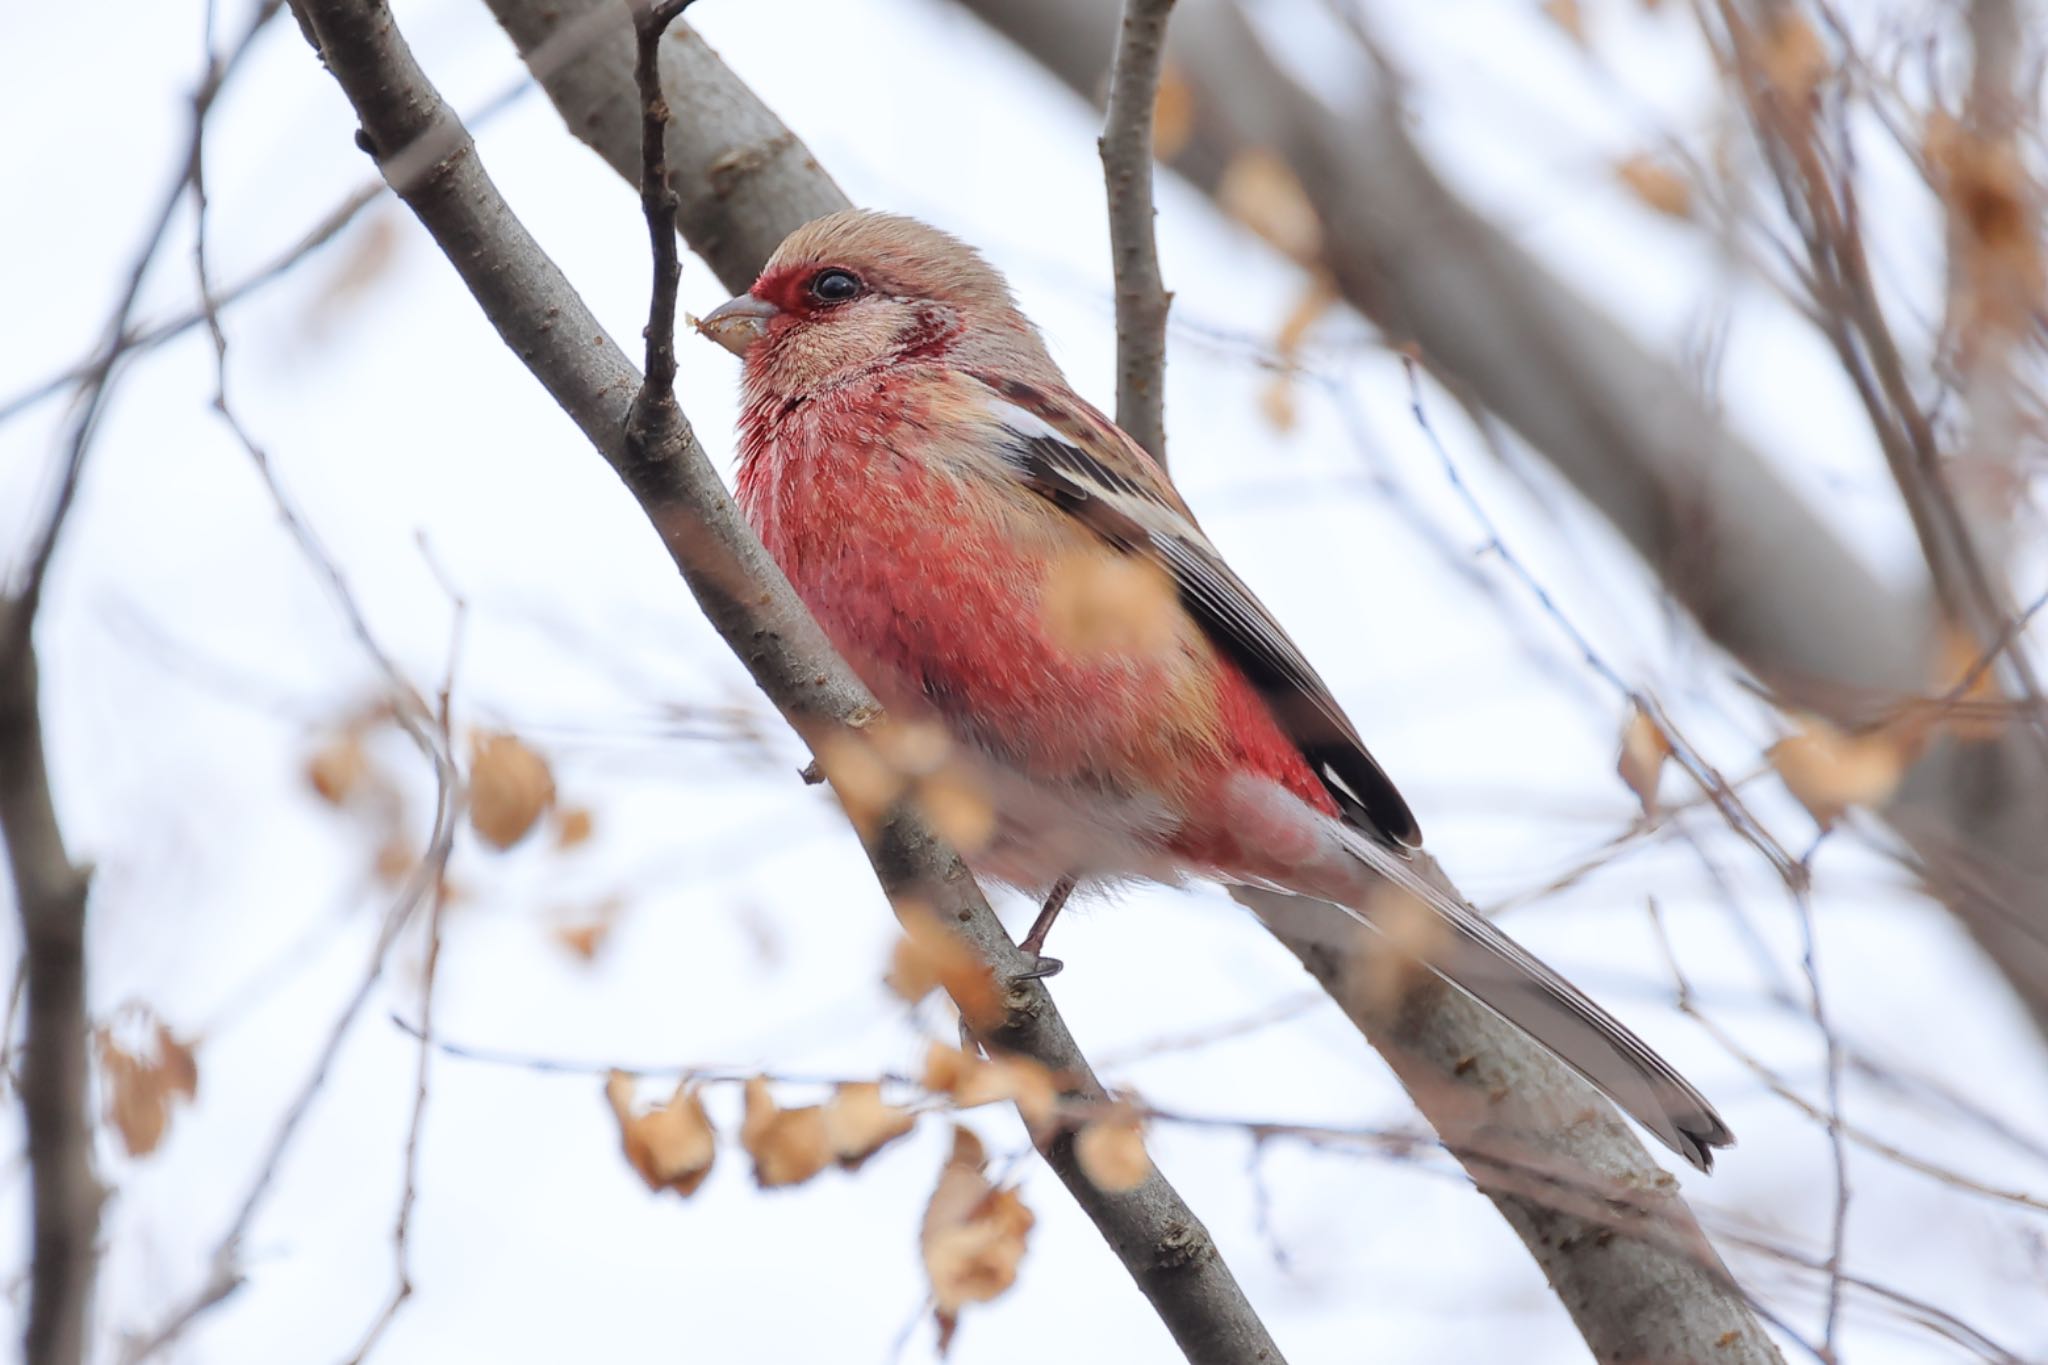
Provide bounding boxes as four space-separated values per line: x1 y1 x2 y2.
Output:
739 435 1225 886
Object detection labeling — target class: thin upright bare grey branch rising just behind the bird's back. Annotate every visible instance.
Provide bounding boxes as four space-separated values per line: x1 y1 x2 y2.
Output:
1098 0 1174 467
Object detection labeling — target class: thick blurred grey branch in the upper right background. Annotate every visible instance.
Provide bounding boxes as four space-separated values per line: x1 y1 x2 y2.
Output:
961 0 2048 1033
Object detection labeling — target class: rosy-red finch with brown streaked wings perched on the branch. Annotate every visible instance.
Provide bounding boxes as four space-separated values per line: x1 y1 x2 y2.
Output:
696 209 1735 1171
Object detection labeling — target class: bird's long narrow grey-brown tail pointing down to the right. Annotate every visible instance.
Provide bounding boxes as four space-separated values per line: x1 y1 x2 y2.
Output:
1239 829 1735 1171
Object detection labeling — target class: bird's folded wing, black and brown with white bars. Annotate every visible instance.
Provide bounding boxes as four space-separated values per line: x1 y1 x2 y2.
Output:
973 375 1421 847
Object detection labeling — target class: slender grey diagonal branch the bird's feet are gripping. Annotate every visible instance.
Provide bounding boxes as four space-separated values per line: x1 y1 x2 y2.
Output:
295 0 1280 1363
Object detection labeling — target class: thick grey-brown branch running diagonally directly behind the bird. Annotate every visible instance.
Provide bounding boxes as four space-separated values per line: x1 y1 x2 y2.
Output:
468 0 1778 1363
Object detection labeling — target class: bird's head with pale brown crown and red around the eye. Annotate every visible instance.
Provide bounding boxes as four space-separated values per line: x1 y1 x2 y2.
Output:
698 209 1057 399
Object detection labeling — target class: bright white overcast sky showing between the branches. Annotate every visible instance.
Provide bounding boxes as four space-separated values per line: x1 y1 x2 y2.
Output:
0 0 2048 1365
